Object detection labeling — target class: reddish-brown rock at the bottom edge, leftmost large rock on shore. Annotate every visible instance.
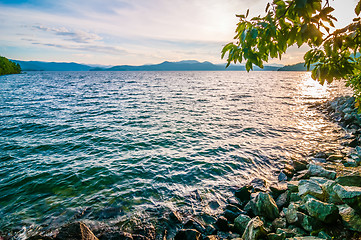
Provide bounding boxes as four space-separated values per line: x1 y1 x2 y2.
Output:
56 222 98 240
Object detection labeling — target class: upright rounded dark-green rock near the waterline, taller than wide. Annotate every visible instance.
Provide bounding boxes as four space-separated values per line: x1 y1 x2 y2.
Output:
255 192 279 220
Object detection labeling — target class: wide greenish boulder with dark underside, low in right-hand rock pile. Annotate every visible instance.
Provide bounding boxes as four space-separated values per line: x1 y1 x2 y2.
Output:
305 198 339 223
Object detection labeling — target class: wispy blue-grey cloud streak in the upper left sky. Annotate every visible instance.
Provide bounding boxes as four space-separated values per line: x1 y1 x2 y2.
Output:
32 26 102 43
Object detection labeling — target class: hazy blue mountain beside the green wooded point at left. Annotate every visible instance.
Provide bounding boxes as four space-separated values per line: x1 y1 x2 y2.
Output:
11 60 92 71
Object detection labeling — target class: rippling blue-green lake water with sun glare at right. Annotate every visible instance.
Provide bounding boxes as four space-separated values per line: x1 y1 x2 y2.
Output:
0 72 346 230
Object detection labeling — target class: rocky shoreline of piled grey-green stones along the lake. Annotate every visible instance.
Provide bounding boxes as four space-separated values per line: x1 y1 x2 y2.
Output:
0 97 361 240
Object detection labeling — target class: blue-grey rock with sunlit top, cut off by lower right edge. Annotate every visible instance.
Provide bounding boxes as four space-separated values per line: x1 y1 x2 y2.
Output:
333 184 361 213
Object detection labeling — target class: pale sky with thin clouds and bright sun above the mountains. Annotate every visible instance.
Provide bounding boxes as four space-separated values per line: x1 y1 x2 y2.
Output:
0 0 357 65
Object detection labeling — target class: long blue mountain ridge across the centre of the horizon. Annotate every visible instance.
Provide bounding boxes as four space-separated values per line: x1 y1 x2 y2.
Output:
90 60 280 71
